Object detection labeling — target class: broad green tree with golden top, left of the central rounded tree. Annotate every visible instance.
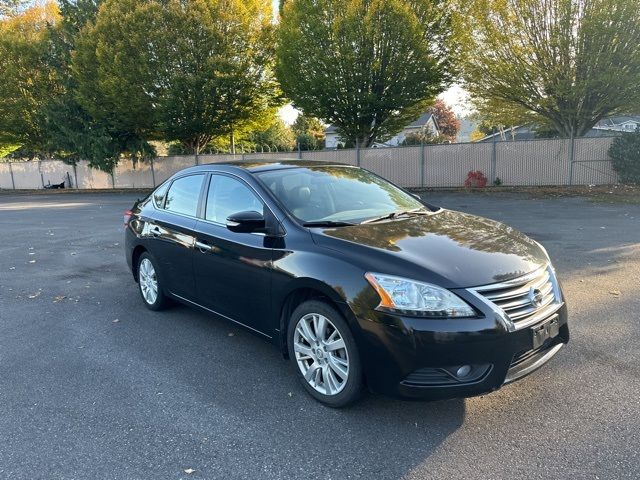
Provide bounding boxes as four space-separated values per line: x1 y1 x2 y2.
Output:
74 0 279 158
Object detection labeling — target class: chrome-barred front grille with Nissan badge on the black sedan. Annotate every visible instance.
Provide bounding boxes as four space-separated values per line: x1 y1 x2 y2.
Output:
473 267 560 326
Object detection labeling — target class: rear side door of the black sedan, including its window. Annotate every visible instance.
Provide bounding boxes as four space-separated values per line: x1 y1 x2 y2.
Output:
142 174 206 300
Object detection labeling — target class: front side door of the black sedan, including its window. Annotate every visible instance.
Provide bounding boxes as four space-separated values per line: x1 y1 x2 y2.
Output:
194 174 273 336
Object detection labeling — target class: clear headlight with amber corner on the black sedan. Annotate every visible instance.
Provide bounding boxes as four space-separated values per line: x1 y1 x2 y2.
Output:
365 272 476 317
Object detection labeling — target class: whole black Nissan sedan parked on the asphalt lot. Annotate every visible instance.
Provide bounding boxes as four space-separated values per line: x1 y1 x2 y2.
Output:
125 161 569 407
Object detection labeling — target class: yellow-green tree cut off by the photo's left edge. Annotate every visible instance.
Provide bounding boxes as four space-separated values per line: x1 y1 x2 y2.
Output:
0 3 59 153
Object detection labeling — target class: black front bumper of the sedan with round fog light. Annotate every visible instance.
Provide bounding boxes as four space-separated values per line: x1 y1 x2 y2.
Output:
358 304 569 400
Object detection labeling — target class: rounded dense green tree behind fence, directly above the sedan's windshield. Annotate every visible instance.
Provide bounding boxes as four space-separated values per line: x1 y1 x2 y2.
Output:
276 0 454 147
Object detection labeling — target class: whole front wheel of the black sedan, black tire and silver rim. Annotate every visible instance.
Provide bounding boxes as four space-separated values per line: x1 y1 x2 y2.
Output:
287 300 363 408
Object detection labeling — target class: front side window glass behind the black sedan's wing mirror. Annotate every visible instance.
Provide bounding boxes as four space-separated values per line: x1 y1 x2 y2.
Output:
205 175 264 224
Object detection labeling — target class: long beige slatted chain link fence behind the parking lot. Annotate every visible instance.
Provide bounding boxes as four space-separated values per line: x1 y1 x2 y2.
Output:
0 137 618 189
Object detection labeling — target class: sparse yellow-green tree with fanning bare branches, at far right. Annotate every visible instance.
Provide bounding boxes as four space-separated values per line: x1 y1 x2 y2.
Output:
464 0 640 137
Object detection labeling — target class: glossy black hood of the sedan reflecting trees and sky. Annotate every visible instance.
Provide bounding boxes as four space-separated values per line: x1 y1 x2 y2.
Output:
312 210 549 288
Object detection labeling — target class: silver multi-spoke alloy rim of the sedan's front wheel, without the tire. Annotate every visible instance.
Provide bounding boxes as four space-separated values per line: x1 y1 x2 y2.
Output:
293 313 349 395
